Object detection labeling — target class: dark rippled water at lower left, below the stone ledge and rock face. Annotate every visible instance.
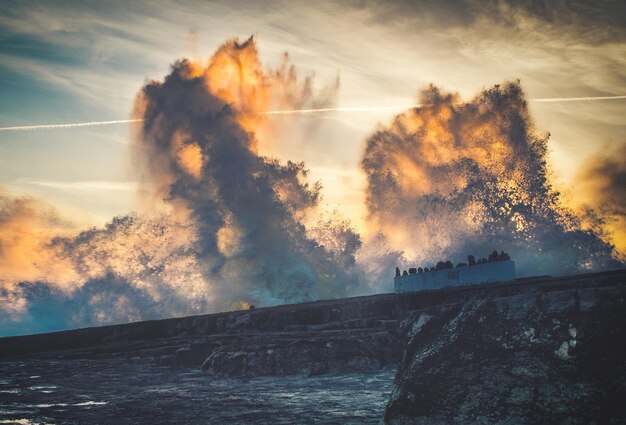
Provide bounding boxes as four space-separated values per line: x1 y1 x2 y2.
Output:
0 359 395 425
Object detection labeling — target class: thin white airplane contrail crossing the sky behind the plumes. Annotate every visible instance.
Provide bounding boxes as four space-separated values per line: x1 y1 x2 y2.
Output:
0 95 626 131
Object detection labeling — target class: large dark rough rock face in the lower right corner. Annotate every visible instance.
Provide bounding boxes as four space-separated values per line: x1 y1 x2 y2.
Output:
385 274 626 424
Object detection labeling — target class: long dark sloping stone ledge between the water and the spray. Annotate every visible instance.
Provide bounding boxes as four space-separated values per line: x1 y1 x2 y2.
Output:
0 271 626 372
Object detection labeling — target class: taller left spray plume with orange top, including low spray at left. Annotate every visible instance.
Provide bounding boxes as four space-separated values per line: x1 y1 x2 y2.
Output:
0 39 360 333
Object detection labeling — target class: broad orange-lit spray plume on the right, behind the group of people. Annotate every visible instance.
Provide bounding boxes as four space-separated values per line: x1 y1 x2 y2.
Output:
362 83 619 275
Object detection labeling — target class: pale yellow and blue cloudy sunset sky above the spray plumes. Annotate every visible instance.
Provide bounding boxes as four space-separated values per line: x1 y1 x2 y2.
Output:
0 1 626 229
